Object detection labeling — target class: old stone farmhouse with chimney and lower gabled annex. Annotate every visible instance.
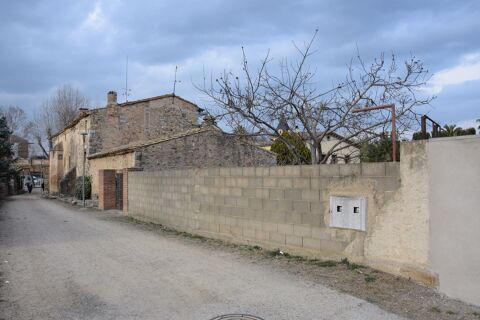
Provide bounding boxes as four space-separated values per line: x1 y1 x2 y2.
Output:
49 91 276 199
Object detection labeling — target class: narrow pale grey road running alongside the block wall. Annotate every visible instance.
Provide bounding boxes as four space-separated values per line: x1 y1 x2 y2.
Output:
0 190 399 320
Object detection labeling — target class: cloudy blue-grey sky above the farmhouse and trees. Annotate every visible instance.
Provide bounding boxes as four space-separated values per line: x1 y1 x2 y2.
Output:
0 0 480 127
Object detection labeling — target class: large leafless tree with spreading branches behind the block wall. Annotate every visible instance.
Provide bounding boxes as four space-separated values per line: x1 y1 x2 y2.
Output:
197 31 433 164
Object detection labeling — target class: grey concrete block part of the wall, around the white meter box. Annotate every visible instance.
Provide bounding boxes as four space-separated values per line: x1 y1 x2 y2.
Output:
128 163 400 263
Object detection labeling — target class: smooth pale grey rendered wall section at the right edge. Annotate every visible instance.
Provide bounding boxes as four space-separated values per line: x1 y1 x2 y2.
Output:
427 136 480 305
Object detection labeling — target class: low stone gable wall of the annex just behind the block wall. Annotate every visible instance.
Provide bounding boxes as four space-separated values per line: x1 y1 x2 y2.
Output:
136 129 276 171
